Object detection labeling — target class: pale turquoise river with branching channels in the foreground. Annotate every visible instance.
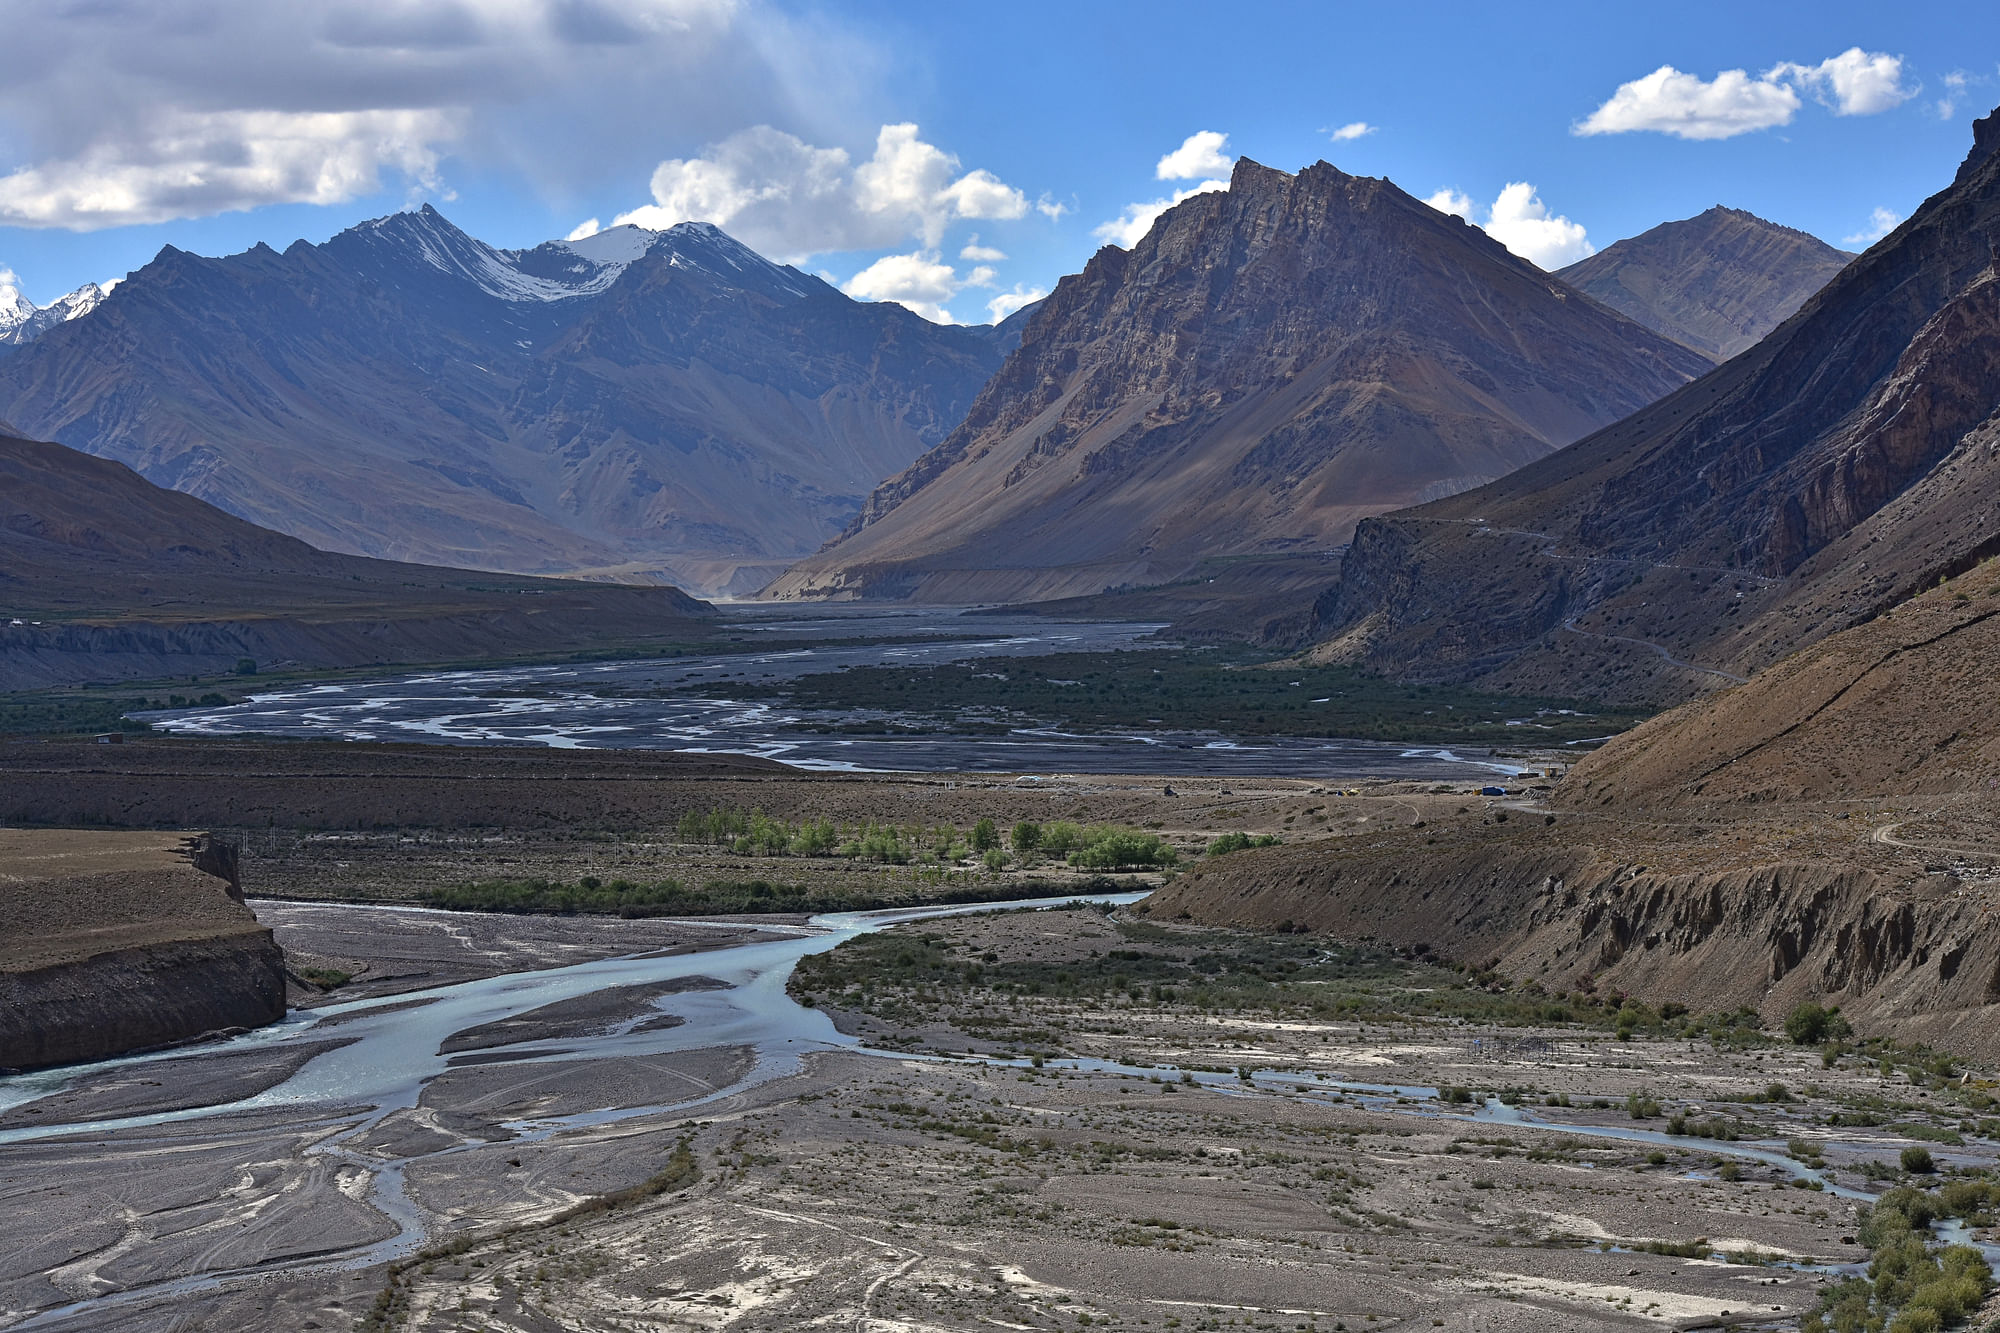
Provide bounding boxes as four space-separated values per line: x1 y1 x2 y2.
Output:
0 893 1952 1329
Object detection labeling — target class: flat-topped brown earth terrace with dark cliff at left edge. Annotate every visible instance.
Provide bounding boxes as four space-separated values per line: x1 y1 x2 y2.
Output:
0 831 284 1069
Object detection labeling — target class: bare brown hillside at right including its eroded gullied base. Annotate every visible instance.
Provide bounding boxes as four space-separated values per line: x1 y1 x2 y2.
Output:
1154 564 2000 1059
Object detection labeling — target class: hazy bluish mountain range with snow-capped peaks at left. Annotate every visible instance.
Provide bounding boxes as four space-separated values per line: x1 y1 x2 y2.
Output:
0 206 1008 592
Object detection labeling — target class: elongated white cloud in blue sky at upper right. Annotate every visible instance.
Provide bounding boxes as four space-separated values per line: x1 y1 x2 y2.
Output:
1572 46 1918 140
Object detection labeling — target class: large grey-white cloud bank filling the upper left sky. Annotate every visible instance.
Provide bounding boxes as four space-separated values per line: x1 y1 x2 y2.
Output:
0 0 884 230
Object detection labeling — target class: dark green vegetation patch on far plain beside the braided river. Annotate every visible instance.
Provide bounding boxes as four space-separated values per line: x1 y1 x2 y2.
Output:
680 648 1648 745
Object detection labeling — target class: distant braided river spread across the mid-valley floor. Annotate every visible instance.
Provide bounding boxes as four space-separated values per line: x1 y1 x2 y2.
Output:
136 606 1518 781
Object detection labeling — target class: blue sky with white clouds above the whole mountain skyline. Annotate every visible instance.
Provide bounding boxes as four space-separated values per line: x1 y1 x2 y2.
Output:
0 0 2000 322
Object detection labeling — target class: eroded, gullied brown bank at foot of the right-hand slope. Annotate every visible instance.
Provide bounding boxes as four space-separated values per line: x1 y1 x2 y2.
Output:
1150 835 2000 1059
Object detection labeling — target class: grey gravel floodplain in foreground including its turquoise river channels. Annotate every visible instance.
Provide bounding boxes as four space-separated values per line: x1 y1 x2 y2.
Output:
0 896 2000 1333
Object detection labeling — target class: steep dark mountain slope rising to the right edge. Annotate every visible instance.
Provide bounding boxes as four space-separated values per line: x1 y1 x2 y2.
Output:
1314 114 2000 701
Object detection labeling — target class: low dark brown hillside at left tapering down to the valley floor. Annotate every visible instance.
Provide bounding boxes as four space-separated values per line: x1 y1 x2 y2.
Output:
0 438 712 689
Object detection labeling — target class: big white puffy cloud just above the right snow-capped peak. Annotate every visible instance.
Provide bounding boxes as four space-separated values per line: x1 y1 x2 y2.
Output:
614 124 1028 262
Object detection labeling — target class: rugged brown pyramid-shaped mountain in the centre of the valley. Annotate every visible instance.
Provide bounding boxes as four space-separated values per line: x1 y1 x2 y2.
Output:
760 160 1710 602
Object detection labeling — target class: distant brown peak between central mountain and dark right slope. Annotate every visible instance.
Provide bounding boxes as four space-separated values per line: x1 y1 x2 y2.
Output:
1556 204 1854 362
